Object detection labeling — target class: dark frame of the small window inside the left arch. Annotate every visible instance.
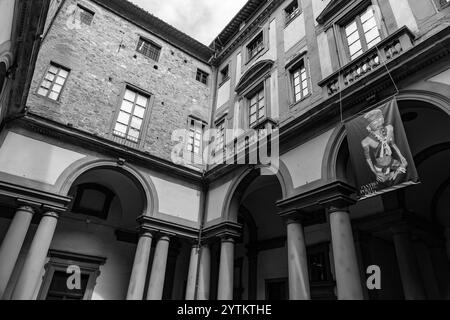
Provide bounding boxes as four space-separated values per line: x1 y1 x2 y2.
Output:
71 183 116 220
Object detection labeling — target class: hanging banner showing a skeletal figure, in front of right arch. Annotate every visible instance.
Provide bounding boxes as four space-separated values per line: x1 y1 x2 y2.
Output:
345 99 419 200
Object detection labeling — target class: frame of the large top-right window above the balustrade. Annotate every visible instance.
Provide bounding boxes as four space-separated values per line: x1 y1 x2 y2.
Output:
338 1 386 62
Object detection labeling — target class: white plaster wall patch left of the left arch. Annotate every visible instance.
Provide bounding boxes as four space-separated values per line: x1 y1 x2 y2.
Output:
0 132 85 185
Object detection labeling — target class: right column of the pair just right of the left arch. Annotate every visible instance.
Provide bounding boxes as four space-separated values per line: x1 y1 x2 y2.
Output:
147 236 170 300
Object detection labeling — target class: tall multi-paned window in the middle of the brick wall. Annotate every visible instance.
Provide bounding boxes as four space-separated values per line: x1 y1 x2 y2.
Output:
114 87 150 143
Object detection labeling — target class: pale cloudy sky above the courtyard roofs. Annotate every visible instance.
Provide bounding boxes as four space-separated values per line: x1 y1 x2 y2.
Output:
129 0 247 45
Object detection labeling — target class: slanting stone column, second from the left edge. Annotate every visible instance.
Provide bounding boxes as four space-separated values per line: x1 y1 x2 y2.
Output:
12 212 59 300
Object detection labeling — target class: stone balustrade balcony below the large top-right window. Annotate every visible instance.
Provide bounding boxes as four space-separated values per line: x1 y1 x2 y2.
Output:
319 27 414 96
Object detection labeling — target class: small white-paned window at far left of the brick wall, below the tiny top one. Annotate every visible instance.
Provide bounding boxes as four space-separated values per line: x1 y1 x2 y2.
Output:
38 63 70 101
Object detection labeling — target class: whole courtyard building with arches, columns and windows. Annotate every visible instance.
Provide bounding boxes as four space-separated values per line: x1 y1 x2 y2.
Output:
0 0 450 300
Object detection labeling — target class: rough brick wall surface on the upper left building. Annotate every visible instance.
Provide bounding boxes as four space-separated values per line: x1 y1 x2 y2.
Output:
27 0 211 164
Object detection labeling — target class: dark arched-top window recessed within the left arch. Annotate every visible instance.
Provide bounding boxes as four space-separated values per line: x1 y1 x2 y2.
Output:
72 183 115 220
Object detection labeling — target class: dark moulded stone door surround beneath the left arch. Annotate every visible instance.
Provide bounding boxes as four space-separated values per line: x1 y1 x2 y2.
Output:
37 249 107 300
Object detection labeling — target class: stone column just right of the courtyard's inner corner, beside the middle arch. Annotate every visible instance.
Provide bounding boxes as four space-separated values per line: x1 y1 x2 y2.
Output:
217 237 234 300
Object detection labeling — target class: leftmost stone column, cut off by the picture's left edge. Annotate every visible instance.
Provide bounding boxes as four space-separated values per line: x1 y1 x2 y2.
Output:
0 206 34 299
